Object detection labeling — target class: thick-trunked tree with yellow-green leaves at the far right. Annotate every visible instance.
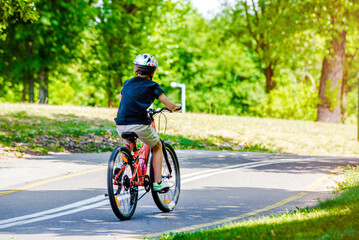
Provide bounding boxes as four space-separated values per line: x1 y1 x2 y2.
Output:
302 0 359 123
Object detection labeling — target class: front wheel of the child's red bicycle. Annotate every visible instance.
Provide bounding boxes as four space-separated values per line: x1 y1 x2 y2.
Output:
150 141 181 212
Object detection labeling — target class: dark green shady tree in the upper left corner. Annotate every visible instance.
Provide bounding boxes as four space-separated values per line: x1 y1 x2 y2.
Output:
0 0 91 103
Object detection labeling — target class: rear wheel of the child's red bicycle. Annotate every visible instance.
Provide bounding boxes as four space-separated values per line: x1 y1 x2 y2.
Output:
107 147 138 220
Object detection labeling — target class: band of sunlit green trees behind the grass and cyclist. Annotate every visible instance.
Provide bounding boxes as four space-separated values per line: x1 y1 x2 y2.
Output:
0 0 359 123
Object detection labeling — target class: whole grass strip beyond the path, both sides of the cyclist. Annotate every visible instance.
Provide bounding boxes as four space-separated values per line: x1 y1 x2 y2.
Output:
0 103 359 157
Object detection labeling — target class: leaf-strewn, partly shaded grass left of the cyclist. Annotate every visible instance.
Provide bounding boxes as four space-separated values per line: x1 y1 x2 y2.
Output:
0 105 118 153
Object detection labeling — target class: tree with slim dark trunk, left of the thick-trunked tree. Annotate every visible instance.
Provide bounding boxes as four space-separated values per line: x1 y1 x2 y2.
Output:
228 0 300 93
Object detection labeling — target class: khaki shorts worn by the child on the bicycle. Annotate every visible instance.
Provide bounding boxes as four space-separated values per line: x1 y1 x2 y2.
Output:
117 124 160 148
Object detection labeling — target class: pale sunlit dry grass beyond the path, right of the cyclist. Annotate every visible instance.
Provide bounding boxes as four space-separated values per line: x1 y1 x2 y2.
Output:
162 114 359 157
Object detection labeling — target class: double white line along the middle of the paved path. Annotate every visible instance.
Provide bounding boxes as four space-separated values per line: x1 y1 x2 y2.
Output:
0 159 308 229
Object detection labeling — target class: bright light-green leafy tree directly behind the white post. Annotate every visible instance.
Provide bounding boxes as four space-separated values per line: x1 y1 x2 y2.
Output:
145 3 265 115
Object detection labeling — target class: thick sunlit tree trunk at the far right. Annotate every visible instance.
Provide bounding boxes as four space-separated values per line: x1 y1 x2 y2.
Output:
317 31 346 123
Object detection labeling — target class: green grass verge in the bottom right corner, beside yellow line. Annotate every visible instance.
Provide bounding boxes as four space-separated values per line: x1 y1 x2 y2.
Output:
159 167 359 240
